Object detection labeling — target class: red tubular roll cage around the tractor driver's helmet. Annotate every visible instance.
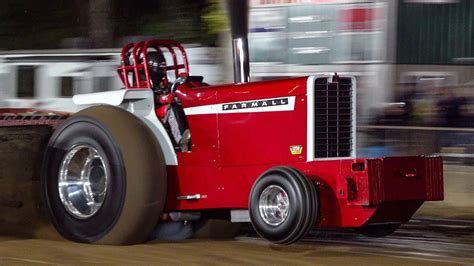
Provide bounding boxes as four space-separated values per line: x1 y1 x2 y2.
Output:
117 40 189 89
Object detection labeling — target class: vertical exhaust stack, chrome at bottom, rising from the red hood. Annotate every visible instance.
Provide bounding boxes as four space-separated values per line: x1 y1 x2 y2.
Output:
227 0 250 83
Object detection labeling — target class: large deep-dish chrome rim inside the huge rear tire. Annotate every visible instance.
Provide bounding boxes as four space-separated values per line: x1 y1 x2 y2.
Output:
58 145 108 219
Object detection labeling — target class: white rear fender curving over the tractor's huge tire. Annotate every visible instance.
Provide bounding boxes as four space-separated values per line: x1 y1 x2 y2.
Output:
72 89 178 165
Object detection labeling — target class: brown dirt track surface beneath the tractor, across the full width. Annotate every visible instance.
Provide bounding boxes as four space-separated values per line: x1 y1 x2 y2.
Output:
0 218 474 265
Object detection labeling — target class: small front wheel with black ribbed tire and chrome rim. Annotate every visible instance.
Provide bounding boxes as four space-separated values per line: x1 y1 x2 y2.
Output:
249 167 318 244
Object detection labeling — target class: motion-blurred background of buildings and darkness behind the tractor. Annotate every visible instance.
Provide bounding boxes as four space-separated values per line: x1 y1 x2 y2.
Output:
0 0 474 168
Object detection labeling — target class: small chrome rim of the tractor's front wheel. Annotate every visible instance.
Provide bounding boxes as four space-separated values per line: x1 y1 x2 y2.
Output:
258 185 290 226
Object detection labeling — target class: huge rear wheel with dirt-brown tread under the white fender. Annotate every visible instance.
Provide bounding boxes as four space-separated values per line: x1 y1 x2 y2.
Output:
41 106 167 245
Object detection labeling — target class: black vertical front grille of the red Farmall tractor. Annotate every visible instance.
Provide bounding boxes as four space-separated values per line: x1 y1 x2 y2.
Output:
314 78 354 158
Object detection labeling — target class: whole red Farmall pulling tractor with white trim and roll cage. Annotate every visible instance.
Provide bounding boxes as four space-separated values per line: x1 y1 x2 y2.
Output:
0 1 443 244
